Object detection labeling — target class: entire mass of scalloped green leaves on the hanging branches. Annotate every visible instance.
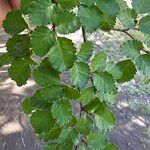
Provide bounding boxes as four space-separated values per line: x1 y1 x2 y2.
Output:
0 0 150 150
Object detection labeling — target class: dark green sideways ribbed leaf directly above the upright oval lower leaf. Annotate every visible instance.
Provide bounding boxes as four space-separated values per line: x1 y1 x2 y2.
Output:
40 85 64 102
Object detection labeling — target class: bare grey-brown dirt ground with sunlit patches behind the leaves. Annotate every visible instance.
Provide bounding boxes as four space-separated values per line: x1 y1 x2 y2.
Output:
0 31 150 150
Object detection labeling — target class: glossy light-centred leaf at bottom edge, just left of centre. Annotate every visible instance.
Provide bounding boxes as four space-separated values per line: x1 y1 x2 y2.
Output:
59 127 80 150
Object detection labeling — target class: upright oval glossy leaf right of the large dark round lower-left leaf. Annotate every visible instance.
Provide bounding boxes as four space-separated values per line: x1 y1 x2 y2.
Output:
51 99 72 125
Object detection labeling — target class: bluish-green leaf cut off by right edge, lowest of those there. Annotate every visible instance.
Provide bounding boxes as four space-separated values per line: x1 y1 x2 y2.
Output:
136 54 150 77
